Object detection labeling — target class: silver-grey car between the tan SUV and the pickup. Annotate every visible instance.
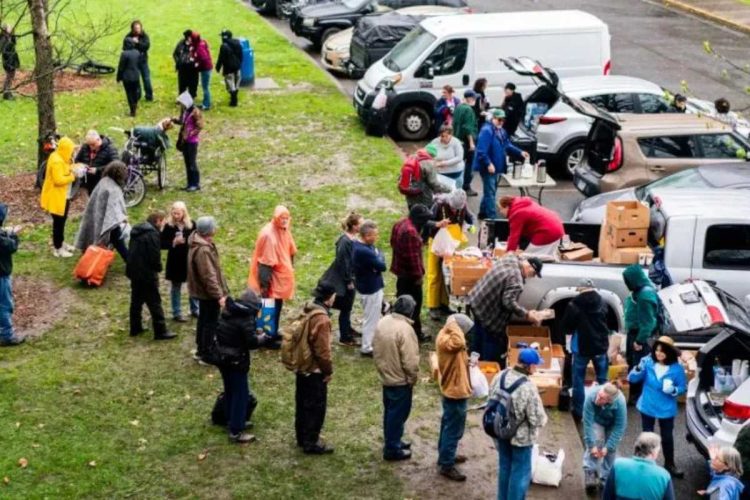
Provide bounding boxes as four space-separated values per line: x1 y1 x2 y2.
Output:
571 163 750 224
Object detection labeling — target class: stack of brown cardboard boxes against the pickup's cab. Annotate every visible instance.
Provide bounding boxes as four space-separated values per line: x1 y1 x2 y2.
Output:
599 201 653 265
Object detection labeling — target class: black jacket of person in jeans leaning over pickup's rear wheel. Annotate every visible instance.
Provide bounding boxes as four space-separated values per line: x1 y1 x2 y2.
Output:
562 291 609 357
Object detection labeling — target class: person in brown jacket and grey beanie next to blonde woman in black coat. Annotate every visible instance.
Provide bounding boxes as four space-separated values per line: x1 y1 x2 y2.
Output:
188 217 229 362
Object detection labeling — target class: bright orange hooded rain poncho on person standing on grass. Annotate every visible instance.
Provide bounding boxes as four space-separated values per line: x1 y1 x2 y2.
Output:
247 206 297 300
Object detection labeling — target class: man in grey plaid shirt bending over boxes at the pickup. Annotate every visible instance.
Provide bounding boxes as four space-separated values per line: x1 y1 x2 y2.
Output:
469 254 542 368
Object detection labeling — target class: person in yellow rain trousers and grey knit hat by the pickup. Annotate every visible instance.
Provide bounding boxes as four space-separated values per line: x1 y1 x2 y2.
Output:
427 189 474 321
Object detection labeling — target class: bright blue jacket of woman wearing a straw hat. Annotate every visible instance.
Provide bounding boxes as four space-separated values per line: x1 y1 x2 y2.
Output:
628 356 687 418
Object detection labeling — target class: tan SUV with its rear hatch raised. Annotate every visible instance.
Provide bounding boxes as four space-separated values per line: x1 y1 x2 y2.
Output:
573 113 750 196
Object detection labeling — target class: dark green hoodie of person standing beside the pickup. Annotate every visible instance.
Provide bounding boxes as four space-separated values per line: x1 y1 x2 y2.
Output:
622 264 659 344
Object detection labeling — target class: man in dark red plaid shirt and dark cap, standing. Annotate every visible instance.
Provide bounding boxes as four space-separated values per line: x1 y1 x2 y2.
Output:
391 203 432 342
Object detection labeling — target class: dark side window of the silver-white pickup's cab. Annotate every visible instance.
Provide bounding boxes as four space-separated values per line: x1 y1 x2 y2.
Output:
703 224 750 269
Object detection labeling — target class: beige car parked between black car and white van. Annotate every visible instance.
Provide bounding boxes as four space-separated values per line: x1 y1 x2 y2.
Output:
320 5 471 78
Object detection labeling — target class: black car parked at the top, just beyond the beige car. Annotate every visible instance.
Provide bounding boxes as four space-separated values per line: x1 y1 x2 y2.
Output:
290 0 466 48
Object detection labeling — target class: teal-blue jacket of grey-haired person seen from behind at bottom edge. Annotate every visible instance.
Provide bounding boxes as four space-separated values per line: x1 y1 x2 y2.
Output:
602 457 674 500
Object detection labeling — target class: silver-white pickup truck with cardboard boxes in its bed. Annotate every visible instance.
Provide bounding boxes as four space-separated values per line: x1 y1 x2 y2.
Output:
490 189 750 340
